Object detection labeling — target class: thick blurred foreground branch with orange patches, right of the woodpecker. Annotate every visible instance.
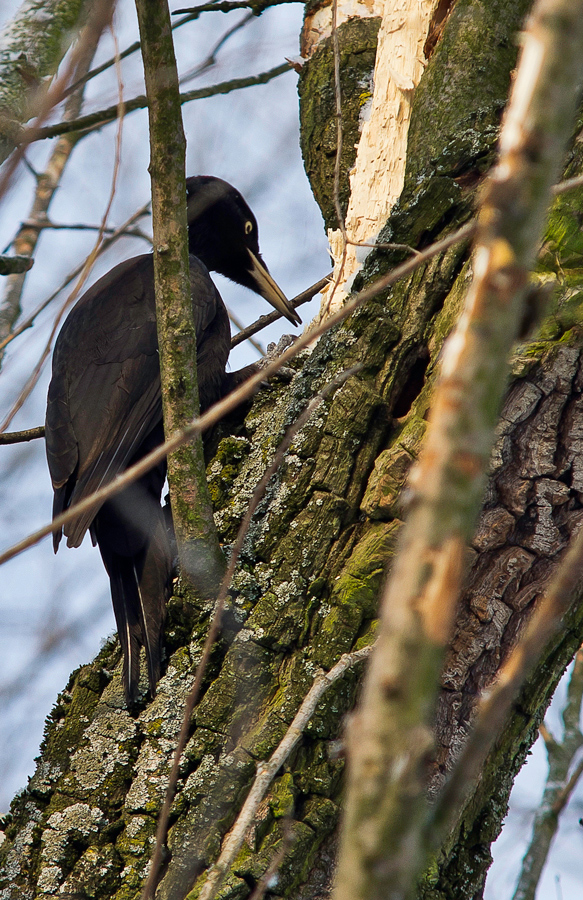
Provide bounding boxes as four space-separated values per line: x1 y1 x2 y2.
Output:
335 0 583 900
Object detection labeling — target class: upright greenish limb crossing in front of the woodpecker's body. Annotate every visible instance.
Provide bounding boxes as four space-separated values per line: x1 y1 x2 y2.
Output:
136 0 224 594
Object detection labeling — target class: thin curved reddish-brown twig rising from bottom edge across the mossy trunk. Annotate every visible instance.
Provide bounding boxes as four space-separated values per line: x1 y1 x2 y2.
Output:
142 366 361 900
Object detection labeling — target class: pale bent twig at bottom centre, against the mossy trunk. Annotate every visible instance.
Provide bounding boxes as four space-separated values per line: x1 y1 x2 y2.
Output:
199 645 373 900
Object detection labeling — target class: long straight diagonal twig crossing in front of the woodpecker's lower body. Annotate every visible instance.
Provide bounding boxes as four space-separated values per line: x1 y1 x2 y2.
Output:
0 220 476 565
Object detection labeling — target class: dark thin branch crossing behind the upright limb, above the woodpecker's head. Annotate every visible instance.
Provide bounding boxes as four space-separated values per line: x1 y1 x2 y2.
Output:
32 62 292 143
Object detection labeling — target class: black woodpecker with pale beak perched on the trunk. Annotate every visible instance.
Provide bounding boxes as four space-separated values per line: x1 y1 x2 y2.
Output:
46 176 301 704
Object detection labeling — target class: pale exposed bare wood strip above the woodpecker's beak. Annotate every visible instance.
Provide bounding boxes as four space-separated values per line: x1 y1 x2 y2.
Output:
320 0 436 318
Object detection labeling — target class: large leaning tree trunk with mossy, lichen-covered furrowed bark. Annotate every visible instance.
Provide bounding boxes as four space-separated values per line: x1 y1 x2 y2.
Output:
0 0 583 900
